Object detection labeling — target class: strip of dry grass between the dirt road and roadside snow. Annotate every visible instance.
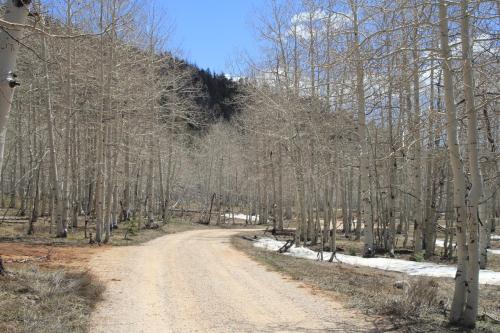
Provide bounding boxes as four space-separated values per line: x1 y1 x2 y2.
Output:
233 234 500 333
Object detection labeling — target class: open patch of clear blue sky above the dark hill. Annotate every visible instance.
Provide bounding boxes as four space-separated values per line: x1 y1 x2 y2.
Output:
157 0 265 74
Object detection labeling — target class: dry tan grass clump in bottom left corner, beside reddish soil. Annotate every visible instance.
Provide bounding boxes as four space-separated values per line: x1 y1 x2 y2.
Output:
0 266 104 333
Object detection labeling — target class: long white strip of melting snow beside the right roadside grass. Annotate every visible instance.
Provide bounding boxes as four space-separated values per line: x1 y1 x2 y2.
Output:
254 238 500 285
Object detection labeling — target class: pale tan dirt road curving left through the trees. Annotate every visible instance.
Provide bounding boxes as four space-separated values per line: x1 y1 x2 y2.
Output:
90 229 379 333
